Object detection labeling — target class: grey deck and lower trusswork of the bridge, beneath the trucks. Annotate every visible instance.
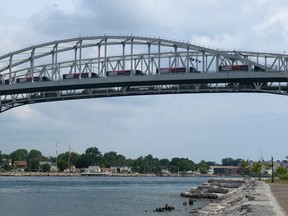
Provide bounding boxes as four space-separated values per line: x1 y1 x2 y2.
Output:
0 75 288 112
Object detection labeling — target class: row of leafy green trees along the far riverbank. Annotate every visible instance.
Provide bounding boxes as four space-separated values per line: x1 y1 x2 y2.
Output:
0 147 215 174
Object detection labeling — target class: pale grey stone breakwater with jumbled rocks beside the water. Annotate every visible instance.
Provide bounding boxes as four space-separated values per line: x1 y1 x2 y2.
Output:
181 179 286 216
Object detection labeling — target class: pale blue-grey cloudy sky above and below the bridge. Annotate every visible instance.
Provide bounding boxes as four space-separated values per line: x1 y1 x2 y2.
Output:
0 0 288 163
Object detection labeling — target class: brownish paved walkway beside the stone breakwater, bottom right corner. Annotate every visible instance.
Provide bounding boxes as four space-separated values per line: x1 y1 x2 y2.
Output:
269 183 288 215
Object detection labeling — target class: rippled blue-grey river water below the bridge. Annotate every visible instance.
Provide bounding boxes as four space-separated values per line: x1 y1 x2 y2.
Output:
0 177 208 216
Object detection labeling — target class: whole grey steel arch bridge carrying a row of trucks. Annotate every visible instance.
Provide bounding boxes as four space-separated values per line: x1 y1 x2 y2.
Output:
0 35 288 112
